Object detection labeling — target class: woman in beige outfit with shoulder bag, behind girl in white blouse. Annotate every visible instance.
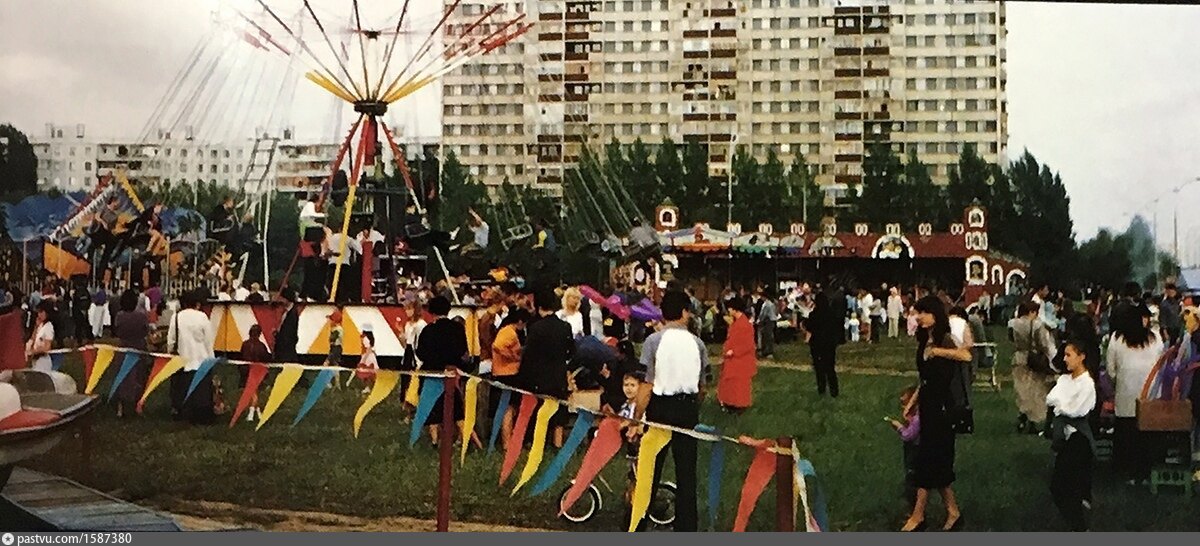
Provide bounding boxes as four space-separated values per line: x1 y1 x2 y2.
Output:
1008 300 1058 433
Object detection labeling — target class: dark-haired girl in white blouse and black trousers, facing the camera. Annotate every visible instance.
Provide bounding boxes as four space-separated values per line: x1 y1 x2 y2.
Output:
1046 342 1096 532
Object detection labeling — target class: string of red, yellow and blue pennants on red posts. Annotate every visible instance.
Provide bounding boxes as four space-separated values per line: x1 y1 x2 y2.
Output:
50 344 829 532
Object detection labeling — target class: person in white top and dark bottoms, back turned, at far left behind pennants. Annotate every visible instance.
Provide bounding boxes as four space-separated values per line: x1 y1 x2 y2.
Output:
167 293 215 425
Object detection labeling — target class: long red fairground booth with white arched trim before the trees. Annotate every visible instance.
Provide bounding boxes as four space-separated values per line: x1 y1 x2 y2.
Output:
643 204 1027 302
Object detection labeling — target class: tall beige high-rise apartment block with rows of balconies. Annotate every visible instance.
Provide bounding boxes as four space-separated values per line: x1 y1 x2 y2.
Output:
443 0 1008 194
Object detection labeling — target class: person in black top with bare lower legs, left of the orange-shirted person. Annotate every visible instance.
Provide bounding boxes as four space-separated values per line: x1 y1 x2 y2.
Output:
414 296 469 445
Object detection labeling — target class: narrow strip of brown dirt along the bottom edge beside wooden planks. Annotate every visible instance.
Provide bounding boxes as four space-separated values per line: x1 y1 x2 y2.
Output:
168 500 548 533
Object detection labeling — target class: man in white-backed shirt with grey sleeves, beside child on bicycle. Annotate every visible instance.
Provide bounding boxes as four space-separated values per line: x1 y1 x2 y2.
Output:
642 292 708 532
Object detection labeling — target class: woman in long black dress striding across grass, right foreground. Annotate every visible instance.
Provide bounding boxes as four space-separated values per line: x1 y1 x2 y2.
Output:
901 296 971 530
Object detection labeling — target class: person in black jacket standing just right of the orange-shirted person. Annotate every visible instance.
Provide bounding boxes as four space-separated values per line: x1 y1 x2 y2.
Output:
517 288 575 448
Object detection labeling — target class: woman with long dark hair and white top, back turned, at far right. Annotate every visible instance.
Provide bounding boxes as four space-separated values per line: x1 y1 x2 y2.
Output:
1105 305 1163 482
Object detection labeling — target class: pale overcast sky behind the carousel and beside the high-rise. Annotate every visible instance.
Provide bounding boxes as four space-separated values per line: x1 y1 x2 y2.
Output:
0 0 1200 262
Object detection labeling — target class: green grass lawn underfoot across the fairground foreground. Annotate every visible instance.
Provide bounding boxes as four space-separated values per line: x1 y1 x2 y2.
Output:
28 328 1200 530
